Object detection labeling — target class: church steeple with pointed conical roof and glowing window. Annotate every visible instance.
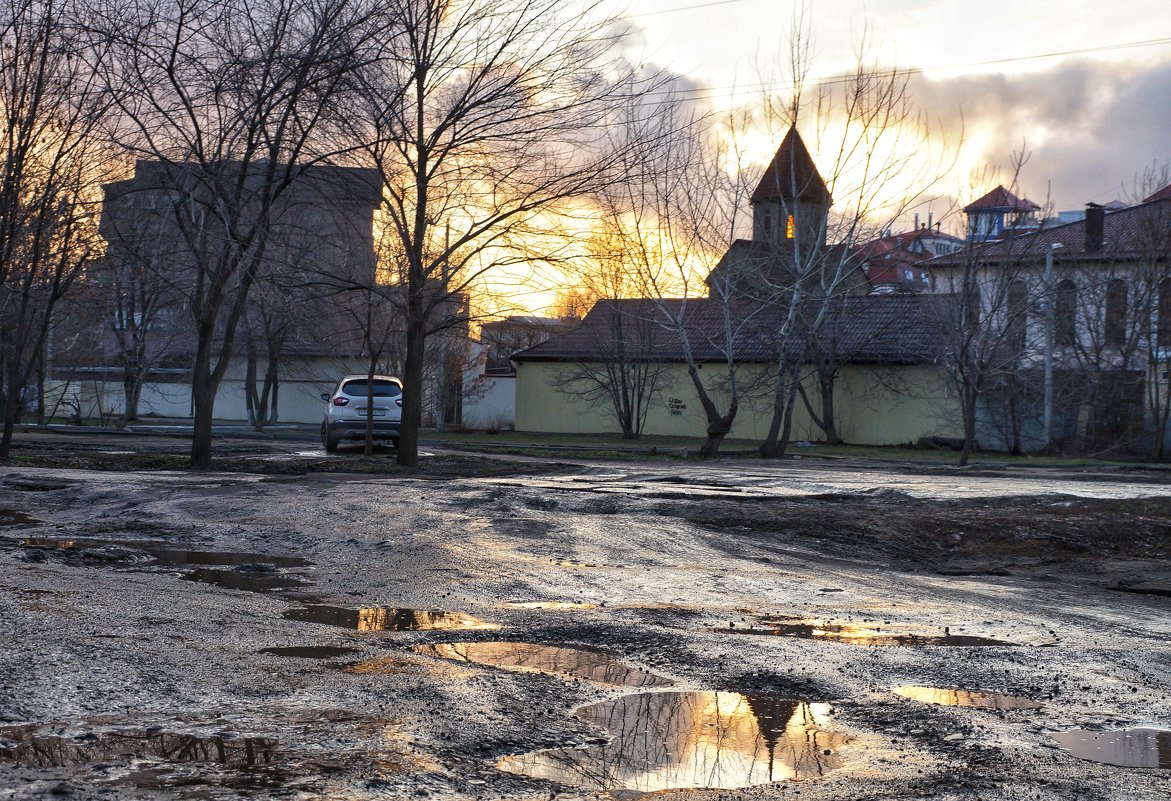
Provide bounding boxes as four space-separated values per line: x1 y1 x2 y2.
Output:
752 125 834 251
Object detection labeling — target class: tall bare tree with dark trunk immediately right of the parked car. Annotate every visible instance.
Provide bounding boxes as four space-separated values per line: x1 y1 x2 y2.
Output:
348 0 653 466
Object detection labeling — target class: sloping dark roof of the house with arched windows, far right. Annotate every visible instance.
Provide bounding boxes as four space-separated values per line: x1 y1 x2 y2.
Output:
926 198 1171 269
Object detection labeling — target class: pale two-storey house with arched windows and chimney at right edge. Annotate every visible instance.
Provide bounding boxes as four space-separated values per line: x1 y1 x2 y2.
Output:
926 187 1171 452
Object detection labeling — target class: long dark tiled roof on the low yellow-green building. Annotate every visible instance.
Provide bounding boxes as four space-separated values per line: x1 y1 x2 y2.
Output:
513 295 951 364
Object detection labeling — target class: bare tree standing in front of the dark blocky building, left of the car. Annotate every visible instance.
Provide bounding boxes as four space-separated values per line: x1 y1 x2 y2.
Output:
95 0 389 468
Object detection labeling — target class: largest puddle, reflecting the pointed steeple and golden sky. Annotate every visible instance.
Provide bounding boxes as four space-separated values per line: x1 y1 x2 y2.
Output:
497 692 851 793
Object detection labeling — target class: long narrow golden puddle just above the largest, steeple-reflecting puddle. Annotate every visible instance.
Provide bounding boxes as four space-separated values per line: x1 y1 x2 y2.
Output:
412 642 674 687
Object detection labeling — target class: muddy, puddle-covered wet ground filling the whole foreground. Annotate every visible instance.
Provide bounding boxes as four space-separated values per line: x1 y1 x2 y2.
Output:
0 439 1171 801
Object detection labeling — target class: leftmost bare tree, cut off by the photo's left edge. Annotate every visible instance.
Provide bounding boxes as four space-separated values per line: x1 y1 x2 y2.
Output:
0 0 109 458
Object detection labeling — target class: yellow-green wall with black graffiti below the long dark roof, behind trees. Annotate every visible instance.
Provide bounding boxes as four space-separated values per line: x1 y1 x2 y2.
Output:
516 362 963 445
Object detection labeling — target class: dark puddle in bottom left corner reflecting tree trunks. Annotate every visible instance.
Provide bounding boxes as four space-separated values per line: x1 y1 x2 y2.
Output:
0 726 276 767
